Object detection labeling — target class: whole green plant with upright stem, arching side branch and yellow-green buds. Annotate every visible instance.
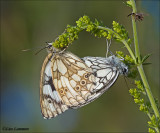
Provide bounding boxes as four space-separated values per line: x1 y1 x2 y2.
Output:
52 3 160 133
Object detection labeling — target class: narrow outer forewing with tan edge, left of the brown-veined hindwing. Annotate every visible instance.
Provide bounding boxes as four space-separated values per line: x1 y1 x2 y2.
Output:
40 53 68 118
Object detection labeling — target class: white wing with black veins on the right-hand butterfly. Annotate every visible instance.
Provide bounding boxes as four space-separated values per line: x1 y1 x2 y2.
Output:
82 57 119 104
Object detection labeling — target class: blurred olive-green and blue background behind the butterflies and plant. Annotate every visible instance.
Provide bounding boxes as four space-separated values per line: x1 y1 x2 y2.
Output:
0 0 160 132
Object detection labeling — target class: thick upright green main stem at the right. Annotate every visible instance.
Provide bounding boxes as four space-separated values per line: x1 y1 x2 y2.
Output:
130 0 159 117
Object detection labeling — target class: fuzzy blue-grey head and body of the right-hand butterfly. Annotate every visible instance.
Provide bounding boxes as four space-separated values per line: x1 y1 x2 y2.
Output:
107 55 128 76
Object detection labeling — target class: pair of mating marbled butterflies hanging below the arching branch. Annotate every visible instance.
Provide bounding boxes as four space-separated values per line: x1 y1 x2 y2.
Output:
40 43 128 118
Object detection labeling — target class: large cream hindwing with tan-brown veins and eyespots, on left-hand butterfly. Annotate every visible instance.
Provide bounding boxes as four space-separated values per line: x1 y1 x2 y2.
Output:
51 52 95 108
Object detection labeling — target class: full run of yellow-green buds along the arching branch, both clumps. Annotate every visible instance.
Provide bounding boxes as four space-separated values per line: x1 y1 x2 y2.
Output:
52 15 131 49
